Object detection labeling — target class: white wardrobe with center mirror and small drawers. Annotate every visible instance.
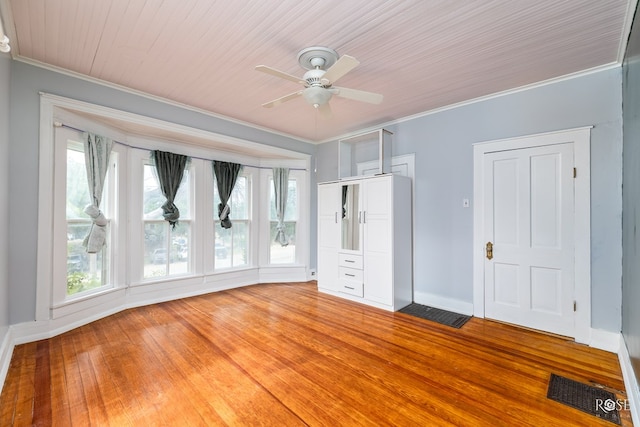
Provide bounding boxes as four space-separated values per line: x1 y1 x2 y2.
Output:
318 174 412 311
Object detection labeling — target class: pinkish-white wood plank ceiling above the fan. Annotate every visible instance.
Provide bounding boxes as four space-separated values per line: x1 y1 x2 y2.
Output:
0 0 637 142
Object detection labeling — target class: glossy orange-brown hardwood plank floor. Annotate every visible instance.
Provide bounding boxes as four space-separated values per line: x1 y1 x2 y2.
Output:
0 283 631 426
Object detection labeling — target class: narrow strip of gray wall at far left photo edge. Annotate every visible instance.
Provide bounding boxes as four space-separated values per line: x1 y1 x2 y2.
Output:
0 53 11 342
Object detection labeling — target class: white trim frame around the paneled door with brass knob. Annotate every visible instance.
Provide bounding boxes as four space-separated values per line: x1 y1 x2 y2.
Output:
473 127 591 344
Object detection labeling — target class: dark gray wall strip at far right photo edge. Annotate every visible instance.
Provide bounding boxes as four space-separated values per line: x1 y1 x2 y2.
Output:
622 3 640 383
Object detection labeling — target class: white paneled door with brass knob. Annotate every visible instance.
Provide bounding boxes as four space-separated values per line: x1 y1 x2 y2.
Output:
483 143 575 337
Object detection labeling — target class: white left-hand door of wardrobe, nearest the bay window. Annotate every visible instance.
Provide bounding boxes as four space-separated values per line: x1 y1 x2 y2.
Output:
318 183 342 290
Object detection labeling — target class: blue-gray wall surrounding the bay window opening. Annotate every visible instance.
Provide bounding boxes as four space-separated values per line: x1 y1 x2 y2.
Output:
8 61 316 324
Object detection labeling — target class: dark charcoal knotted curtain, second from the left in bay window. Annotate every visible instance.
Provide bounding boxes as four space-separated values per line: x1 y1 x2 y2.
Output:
151 150 189 228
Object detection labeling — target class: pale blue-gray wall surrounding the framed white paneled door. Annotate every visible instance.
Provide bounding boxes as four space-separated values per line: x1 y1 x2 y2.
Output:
317 68 622 332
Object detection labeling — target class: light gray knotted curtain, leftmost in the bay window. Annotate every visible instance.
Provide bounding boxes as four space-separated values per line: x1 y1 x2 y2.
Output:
82 132 113 254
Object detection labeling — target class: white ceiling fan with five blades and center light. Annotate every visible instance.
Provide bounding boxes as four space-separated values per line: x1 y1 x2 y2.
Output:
256 46 383 115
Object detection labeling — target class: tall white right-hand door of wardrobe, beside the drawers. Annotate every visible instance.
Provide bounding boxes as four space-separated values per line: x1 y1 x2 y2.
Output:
363 176 393 305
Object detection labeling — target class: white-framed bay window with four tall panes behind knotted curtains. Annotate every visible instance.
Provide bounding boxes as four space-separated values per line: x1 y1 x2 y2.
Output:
41 95 309 322
